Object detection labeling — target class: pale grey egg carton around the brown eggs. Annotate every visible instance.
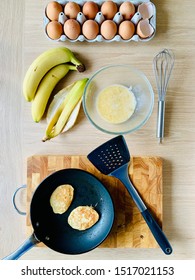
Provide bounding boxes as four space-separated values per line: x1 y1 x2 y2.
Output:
44 0 156 43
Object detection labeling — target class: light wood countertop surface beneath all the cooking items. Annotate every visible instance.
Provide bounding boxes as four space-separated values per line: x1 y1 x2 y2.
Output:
0 0 195 260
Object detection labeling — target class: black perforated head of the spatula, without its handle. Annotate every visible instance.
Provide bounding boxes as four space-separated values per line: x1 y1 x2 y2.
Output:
87 135 130 175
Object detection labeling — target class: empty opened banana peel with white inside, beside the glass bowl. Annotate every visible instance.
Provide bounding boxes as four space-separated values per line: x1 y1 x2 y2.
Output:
42 78 88 142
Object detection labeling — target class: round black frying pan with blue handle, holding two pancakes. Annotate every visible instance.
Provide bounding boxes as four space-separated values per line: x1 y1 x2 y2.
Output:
4 169 114 260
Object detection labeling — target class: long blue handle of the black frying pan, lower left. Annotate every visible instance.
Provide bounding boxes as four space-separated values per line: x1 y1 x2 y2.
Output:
3 233 40 260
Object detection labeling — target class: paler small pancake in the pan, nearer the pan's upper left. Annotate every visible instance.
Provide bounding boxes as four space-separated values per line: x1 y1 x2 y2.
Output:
50 184 74 214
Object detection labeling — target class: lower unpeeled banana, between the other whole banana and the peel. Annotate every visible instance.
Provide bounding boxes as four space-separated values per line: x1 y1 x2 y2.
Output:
31 64 76 122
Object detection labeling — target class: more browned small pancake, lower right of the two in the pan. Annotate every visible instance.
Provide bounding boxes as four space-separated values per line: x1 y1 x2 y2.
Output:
68 206 99 230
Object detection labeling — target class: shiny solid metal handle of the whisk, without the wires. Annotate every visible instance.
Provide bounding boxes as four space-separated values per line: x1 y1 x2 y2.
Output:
156 100 165 142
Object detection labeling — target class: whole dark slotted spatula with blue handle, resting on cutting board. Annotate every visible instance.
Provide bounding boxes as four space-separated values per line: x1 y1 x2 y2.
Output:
87 135 172 255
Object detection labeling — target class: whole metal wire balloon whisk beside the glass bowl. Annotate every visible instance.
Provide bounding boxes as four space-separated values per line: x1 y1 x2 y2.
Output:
153 49 174 143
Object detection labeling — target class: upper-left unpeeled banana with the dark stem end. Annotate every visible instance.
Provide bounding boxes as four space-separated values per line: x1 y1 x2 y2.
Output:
23 47 85 101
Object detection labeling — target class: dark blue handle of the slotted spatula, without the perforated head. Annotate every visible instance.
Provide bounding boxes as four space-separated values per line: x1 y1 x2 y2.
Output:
110 164 172 255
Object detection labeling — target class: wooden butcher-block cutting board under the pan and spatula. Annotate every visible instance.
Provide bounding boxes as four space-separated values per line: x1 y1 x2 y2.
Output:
26 155 163 248
